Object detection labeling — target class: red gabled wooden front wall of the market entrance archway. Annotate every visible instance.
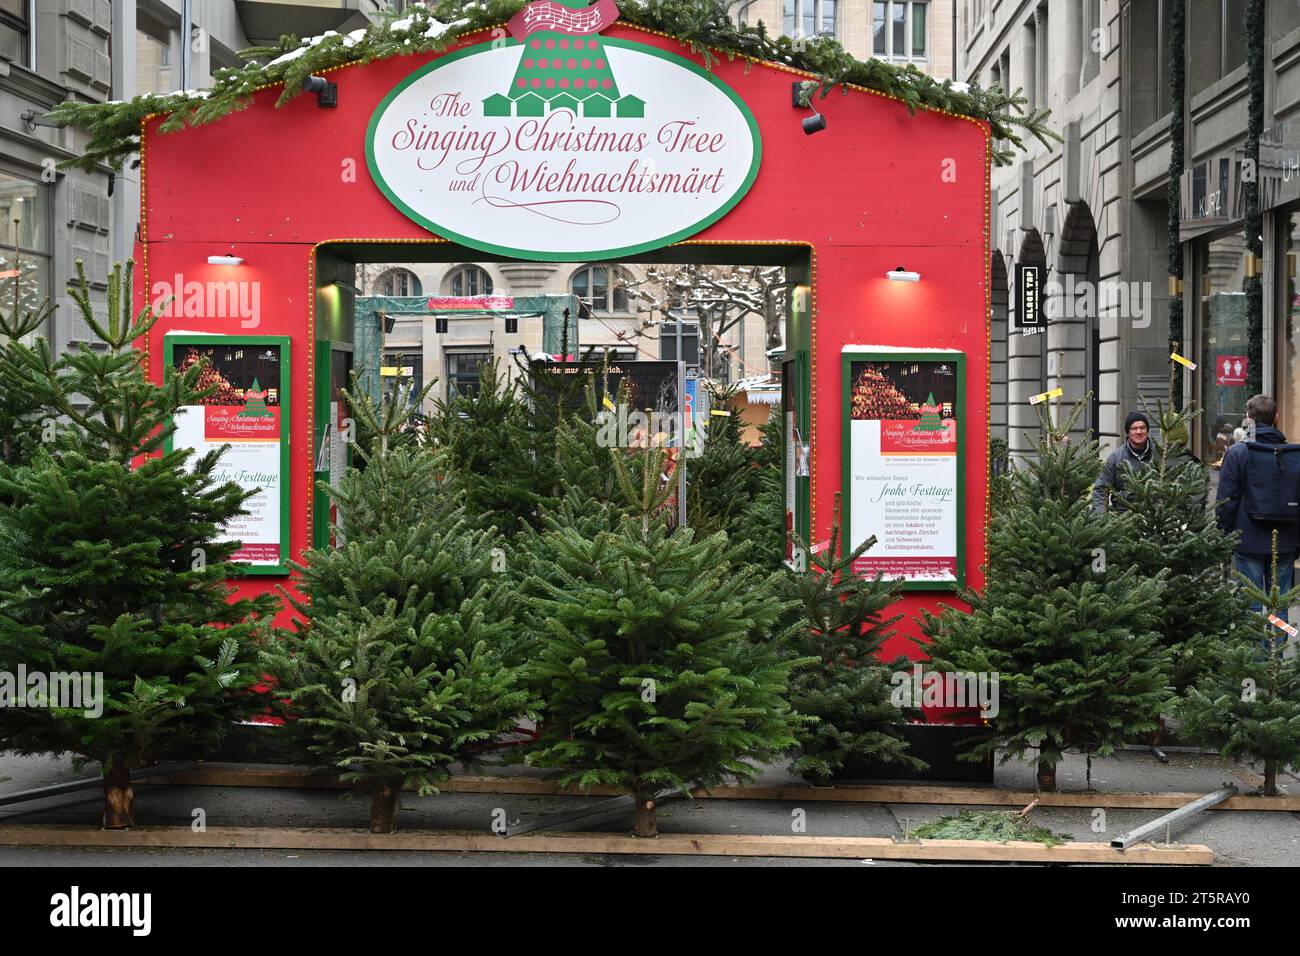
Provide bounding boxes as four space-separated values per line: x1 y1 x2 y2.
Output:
137 23 989 650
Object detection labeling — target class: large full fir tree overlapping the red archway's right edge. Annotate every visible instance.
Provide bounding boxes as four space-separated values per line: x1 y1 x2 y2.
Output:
922 403 1171 790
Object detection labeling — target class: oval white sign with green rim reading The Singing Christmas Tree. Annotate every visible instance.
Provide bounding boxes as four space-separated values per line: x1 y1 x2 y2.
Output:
365 35 762 261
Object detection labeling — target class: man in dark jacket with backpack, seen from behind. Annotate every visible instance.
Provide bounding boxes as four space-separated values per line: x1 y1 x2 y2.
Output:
1214 395 1300 593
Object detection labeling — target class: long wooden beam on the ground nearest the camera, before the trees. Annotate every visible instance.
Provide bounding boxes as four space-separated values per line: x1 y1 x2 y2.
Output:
0 826 1214 866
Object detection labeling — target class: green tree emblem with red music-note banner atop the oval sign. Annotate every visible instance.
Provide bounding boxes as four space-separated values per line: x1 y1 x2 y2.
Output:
484 0 645 118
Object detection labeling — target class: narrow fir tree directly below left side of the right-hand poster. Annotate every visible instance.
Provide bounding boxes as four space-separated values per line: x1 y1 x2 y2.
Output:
785 494 926 784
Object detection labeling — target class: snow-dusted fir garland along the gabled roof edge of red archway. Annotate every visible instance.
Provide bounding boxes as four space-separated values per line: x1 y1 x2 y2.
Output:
49 0 1060 170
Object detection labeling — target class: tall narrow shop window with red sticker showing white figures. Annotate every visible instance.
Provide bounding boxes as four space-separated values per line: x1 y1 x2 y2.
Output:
1195 229 1251 464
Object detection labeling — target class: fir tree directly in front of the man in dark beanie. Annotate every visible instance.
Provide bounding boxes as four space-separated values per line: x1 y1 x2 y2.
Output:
1106 403 1245 693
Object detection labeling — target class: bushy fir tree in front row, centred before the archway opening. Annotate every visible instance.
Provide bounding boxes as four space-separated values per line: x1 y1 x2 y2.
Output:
525 449 811 836
